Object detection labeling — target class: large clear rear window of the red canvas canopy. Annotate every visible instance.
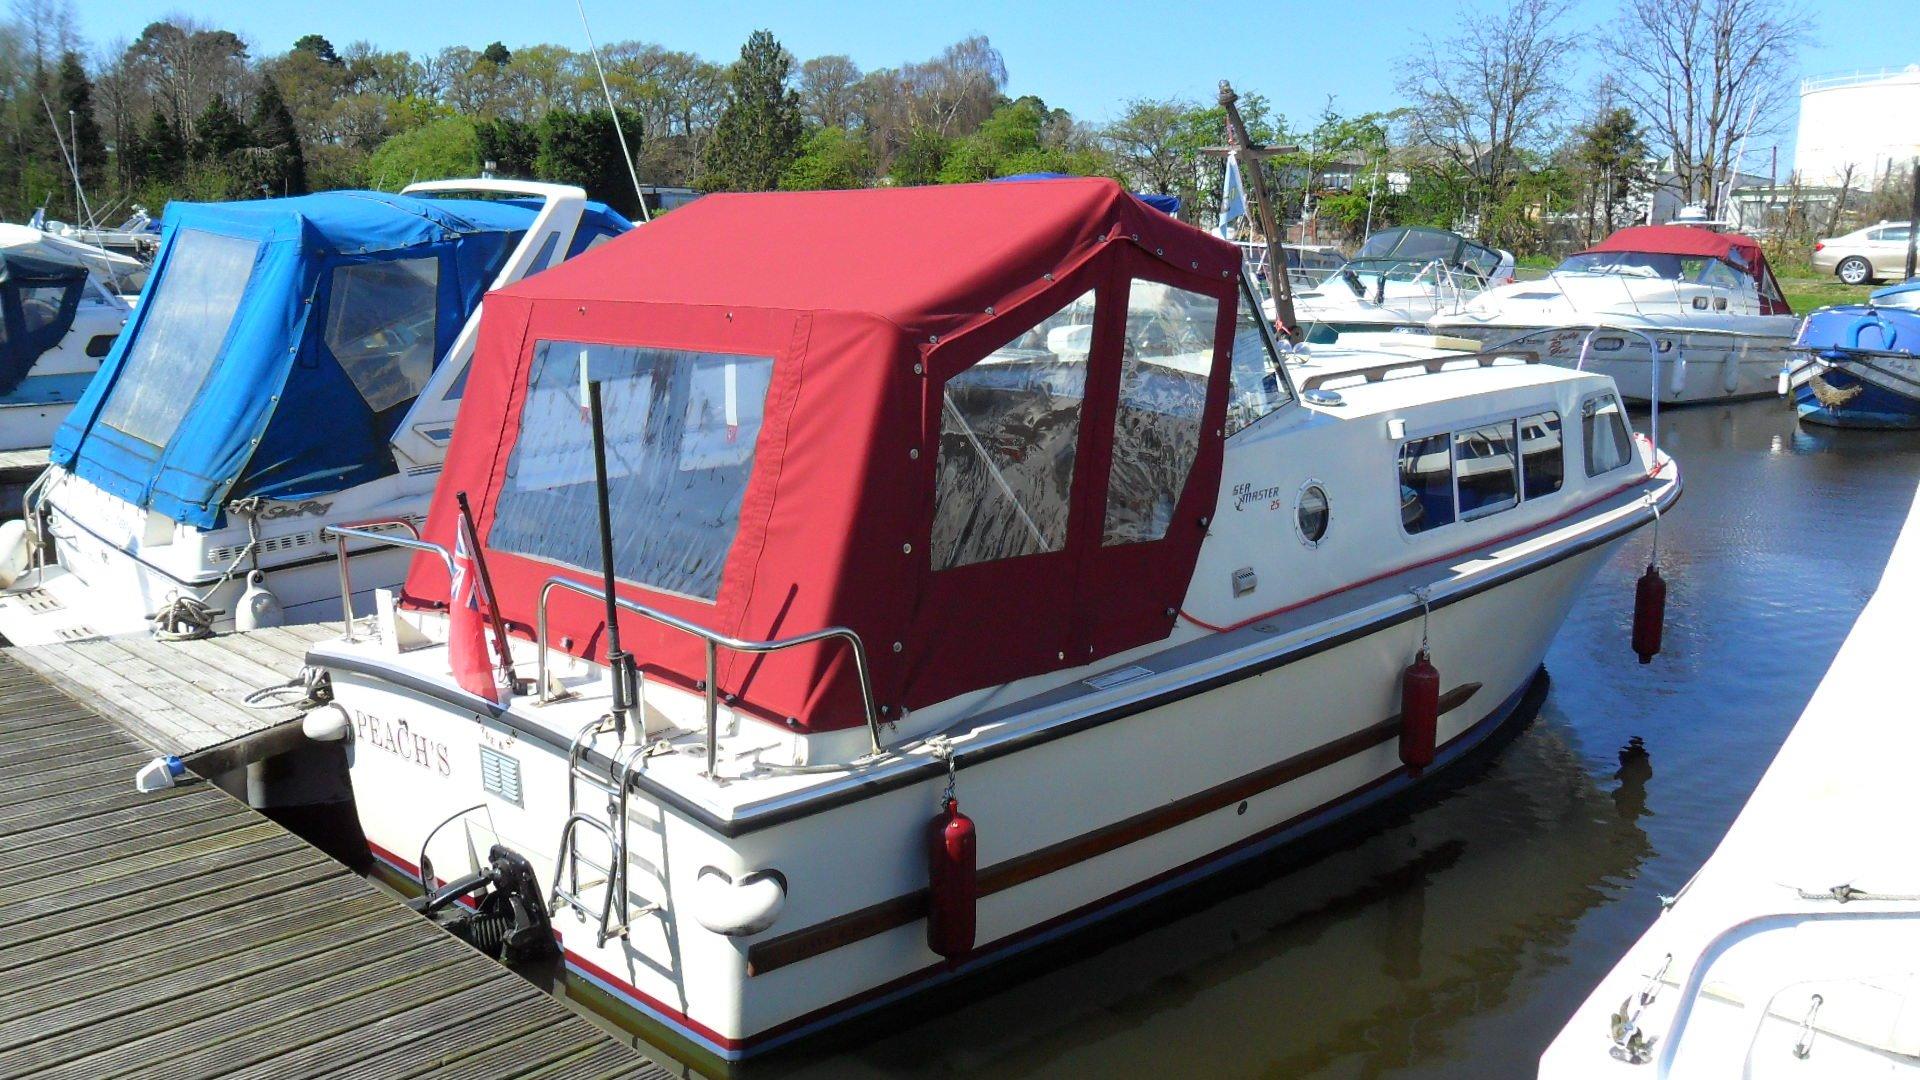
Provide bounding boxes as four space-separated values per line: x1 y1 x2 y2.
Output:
488 342 774 600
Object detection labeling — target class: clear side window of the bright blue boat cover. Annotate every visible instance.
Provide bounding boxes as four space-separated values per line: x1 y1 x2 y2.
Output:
326 256 440 413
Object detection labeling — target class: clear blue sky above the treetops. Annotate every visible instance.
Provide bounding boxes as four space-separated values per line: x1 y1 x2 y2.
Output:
77 0 1920 156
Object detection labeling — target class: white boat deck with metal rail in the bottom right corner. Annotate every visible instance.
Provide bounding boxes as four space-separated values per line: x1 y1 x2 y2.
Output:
1540 484 1920 1080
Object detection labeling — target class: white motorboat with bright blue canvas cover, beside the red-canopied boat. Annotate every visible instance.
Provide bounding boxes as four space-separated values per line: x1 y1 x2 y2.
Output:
0 181 628 644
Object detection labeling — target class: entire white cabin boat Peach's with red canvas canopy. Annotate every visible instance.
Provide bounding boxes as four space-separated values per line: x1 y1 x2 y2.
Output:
295 179 1680 1059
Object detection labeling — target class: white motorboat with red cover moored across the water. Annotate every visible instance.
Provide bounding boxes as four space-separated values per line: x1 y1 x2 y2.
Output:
1428 225 1799 404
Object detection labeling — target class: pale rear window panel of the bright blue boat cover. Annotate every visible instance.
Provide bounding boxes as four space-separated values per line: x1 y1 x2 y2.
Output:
100 229 259 446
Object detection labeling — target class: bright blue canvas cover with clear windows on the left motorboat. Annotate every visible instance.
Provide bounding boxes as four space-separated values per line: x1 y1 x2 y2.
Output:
52 190 628 528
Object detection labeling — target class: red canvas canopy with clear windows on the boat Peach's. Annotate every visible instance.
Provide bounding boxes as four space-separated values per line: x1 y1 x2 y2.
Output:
407 179 1240 730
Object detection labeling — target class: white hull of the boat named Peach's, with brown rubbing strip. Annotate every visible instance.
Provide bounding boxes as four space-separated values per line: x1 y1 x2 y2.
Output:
323 538 1624 1059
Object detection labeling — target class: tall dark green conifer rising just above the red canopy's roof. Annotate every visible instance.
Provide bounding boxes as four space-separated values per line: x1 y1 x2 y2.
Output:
701 31 803 192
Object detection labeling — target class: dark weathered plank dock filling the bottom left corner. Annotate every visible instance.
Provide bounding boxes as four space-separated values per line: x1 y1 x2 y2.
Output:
0 638 670 1080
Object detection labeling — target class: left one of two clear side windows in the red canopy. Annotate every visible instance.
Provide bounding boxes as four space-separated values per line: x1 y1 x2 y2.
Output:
931 290 1094 571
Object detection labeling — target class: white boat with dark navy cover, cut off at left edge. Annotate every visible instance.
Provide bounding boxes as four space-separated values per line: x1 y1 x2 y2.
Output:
0 225 146 449
